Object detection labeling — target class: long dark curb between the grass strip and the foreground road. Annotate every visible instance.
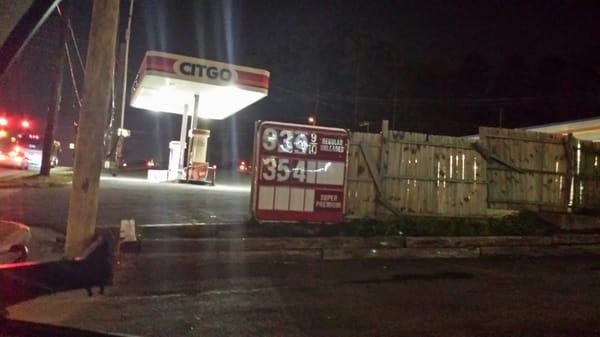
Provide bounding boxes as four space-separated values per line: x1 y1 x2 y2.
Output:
122 235 600 264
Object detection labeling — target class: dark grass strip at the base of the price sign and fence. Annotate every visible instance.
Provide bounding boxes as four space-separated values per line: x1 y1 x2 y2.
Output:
138 211 560 238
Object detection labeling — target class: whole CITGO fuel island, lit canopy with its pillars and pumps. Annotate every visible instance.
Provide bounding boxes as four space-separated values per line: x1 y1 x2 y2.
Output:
131 51 269 182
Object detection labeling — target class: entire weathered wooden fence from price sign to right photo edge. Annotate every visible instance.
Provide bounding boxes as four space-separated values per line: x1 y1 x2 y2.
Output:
346 127 600 218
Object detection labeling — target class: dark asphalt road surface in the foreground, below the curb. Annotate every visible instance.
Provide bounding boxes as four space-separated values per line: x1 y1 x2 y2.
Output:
9 255 600 337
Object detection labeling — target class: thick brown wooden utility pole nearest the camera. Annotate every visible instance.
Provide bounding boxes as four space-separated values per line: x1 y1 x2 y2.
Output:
65 0 119 258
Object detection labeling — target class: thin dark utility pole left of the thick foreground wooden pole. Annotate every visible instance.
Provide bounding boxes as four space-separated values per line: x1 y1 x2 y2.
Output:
40 6 69 176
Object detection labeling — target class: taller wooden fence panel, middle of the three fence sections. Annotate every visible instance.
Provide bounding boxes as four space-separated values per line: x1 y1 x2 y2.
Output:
479 127 573 211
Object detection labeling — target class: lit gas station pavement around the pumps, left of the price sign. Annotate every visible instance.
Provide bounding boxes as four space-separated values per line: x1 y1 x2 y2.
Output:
0 171 250 231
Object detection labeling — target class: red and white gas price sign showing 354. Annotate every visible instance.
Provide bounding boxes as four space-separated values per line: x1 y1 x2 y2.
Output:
252 121 348 222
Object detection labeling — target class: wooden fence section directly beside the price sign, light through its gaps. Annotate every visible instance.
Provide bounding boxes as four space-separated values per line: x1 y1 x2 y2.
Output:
346 130 487 217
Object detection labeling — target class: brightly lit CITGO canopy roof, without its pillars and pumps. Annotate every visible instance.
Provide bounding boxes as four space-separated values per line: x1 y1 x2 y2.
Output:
131 51 269 119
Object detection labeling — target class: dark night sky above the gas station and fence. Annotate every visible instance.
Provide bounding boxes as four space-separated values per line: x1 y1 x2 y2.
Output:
0 0 600 164
